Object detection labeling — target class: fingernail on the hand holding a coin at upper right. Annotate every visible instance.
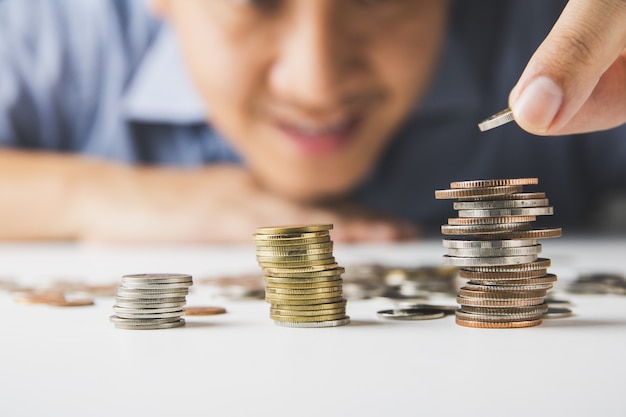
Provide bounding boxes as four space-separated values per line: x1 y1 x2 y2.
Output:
513 76 563 132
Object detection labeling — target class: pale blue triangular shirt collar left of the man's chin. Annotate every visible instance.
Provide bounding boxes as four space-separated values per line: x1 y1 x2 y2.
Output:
122 22 208 124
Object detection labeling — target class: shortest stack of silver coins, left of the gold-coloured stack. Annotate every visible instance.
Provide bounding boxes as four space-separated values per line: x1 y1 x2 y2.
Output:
111 274 193 330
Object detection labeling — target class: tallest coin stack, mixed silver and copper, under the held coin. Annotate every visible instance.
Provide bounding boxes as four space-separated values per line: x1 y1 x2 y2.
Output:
435 178 561 328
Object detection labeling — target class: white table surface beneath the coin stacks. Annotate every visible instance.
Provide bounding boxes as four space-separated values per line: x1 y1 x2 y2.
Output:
0 237 626 417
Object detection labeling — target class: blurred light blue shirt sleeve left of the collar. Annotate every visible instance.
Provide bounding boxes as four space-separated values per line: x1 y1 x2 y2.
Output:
0 0 154 151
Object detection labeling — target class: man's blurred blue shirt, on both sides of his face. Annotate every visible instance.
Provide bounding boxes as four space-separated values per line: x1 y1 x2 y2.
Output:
0 0 626 232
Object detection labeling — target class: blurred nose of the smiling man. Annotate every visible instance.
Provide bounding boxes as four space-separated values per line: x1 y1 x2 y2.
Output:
268 0 363 111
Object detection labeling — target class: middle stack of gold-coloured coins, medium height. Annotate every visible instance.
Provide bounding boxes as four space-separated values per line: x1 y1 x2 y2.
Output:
254 224 350 327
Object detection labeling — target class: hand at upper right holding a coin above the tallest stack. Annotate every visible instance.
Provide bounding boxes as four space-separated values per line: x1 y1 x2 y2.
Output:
509 0 626 135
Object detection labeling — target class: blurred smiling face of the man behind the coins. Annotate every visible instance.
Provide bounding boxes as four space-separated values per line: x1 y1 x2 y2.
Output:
153 0 448 200
